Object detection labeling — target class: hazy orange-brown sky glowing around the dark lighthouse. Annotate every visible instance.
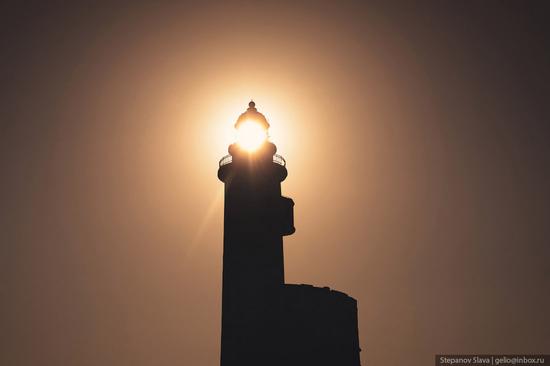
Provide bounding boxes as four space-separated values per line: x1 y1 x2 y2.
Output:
0 1 550 366
